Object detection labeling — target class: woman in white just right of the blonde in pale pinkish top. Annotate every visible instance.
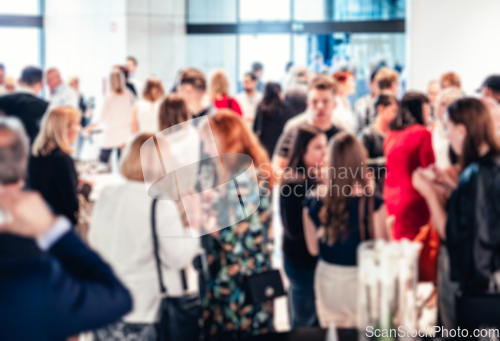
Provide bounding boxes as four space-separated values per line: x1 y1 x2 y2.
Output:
132 76 165 134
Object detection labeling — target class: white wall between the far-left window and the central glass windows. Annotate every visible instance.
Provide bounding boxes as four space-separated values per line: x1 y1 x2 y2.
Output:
44 0 185 107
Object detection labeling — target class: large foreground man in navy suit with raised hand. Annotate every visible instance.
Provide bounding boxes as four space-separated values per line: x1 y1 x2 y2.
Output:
0 117 132 341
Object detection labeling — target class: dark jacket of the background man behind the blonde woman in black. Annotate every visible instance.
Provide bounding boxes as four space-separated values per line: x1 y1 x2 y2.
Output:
0 93 49 143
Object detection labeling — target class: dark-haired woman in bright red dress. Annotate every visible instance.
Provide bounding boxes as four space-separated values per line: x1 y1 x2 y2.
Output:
384 92 434 240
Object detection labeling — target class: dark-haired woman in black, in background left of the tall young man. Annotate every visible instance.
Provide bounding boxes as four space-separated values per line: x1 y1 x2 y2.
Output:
253 82 294 158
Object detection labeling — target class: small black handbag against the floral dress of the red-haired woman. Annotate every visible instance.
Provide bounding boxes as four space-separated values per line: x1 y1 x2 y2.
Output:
245 270 286 305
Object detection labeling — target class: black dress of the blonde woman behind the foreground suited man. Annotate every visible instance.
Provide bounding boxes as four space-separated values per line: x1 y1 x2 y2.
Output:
29 148 78 224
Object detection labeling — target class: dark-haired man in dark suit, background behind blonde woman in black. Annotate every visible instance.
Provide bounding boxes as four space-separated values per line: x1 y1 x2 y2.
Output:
0 66 49 144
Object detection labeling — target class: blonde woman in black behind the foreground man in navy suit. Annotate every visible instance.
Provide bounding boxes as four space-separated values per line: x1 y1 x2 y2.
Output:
29 107 81 224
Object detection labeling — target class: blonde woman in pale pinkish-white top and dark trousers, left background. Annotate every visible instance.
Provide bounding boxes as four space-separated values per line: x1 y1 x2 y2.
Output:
87 68 135 163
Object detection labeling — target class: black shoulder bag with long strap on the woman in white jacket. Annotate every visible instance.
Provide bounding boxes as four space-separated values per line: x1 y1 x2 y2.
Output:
151 199 202 341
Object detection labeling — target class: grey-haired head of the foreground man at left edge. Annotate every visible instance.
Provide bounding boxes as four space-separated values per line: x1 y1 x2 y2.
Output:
0 117 29 189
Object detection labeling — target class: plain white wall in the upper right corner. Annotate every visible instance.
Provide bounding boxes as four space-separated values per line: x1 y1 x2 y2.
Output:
406 0 500 94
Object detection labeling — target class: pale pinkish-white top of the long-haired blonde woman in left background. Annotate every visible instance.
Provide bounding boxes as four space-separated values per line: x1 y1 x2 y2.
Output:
99 90 134 149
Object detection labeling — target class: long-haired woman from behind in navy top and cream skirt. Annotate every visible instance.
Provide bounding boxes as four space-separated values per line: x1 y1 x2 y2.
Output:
303 132 386 328
